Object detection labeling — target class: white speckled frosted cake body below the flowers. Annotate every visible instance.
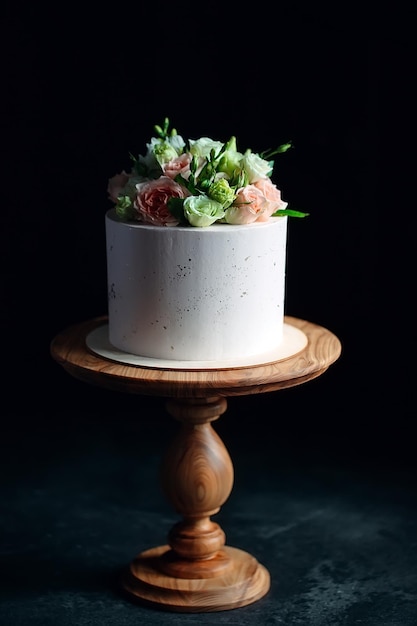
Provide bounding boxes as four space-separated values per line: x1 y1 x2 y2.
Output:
105 209 287 361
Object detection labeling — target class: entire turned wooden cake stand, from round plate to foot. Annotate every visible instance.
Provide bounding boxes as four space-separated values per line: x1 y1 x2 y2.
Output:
51 316 341 613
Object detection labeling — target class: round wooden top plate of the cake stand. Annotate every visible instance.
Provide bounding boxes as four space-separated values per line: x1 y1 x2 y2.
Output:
51 316 342 398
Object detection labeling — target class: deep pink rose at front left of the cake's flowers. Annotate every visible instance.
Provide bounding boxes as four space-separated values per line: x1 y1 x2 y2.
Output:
135 176 189 226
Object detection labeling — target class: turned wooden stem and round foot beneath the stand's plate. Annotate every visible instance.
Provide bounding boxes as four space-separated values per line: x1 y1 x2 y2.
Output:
118 396 270 612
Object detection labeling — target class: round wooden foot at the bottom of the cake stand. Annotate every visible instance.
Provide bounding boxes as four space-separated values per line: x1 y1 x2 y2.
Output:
122 545 270 613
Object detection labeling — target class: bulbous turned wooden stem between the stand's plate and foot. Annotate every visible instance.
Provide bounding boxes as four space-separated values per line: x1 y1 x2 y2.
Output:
161 397 234 564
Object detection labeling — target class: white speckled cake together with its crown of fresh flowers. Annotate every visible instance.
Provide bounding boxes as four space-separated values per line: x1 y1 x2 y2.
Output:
105 119 307 362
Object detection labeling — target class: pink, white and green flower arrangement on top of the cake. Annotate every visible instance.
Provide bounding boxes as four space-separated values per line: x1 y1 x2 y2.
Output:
107 118 308 228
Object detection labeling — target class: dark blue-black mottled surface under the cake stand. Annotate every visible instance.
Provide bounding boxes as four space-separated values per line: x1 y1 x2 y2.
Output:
0 382 417 626
